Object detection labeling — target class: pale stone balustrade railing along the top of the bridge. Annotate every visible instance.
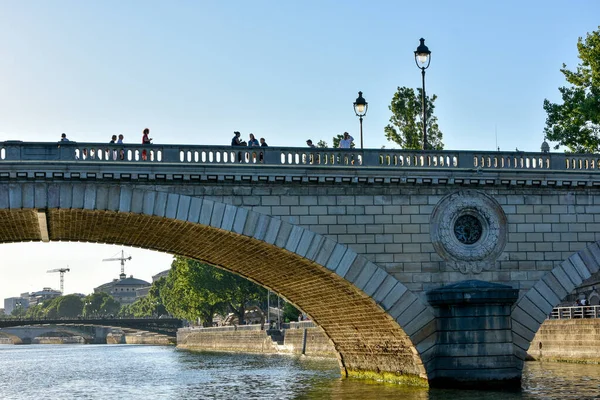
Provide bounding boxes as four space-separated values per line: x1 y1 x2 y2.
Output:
0 141 600 172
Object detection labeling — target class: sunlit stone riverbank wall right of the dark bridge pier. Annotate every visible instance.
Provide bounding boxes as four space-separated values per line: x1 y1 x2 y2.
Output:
528 318 600 364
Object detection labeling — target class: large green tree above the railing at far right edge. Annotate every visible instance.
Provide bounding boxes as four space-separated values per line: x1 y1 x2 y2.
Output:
544 26 600 153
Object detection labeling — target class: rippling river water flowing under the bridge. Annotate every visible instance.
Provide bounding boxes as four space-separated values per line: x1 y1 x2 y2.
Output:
0 345 600 400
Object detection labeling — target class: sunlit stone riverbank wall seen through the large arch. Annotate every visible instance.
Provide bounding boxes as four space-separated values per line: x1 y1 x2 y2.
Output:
177 323 337 358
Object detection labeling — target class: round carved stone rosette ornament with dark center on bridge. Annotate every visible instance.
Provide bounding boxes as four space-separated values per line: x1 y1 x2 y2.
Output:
430 190 508 274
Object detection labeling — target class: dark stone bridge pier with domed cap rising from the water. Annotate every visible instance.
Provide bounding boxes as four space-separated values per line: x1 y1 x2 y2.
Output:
427 280 523 390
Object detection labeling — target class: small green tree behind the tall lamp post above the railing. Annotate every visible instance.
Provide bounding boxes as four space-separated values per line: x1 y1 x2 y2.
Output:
384 87 444 150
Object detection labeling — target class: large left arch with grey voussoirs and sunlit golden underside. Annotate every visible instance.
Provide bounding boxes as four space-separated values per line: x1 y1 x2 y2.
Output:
0 186 435 383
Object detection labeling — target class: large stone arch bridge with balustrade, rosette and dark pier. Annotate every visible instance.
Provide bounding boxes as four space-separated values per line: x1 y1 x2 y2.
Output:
0 142 600 388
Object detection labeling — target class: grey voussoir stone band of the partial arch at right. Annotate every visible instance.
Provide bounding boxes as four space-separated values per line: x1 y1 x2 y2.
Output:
511 242 600 368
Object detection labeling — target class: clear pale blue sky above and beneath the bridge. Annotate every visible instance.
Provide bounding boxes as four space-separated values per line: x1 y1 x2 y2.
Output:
0 0 600 298
